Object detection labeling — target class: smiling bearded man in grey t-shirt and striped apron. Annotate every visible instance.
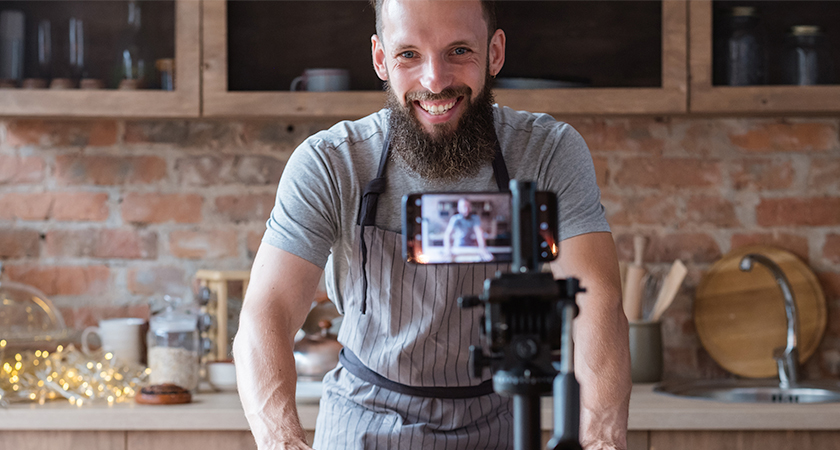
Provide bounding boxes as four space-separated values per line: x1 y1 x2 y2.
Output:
234 0 630 450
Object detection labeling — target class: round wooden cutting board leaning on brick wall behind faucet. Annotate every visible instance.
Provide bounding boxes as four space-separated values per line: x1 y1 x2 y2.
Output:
694 245 827 378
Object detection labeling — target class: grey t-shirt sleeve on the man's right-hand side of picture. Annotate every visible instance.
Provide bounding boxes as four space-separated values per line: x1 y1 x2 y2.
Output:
547 124 610 240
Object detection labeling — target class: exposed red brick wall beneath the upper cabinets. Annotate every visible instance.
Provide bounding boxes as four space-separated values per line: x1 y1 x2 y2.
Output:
0 117 840 378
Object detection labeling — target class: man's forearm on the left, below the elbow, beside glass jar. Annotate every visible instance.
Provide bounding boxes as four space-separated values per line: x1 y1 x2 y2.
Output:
233 310 306 450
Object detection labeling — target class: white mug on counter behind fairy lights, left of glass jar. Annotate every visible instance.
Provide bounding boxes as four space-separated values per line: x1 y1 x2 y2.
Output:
82 317 146 364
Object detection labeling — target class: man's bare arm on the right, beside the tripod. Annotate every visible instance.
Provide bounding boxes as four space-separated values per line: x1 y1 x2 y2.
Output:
551 233 632 450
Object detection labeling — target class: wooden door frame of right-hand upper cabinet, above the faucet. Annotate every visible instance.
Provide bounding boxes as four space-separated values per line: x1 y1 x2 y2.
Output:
689 0 840 114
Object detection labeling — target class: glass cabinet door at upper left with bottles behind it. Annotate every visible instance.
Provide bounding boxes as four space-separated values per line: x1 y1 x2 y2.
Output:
0 0 200 117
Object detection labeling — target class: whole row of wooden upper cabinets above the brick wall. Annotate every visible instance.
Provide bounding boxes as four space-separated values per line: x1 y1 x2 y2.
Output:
0 0 840 118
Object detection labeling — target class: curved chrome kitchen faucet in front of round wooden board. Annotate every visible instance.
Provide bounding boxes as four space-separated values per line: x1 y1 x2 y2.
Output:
739 253 799 388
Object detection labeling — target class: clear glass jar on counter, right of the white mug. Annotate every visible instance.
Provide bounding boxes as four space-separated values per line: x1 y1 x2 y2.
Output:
147 305 201 391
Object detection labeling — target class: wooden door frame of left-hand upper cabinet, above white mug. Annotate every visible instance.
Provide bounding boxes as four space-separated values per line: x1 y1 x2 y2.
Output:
0 0 201 118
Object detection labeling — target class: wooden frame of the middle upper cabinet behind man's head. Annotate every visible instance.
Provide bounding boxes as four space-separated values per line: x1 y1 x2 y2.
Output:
202 0 688 118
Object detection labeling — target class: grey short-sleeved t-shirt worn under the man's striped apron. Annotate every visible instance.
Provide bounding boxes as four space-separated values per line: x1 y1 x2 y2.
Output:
263 106 609 310
